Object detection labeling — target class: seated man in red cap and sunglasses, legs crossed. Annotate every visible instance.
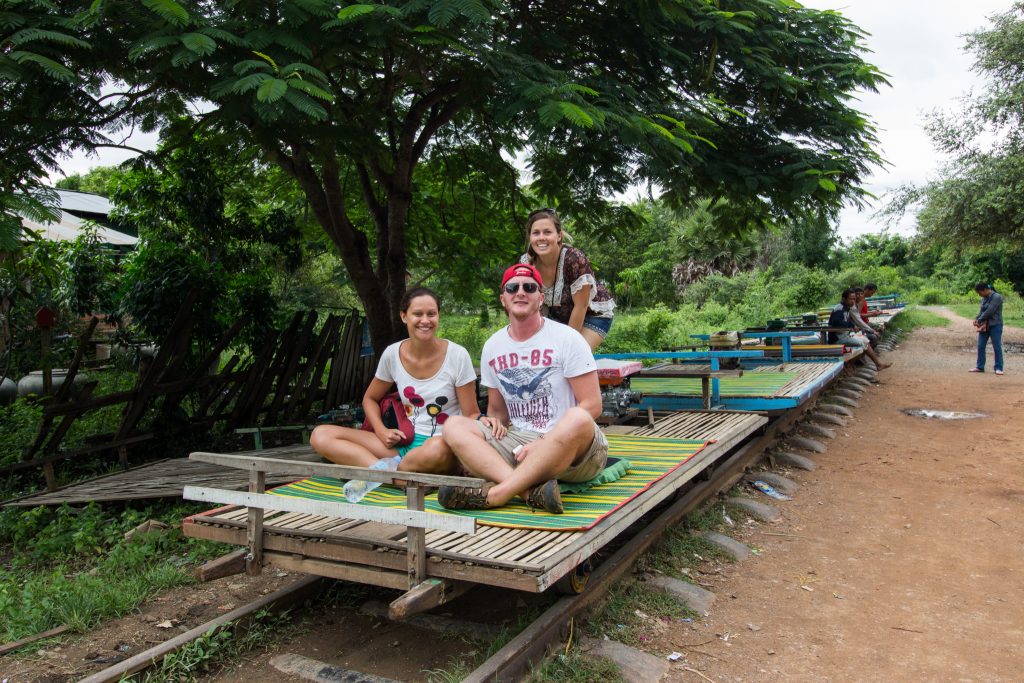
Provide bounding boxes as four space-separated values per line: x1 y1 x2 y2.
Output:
437 263 608 514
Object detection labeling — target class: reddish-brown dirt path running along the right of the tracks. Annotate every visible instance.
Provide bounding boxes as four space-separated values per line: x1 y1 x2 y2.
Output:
647 309 1024 682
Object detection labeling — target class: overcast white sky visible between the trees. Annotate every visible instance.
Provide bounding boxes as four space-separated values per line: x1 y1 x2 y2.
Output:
56 0 1012 242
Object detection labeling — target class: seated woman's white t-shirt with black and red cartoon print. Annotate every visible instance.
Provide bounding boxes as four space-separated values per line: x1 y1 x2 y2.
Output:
375 341 476 436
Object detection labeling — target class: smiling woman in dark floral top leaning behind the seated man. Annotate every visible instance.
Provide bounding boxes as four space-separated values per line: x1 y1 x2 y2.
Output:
519 209 615 351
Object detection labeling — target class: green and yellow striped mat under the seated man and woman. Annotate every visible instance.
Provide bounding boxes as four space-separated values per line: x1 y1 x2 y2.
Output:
267 434 711 531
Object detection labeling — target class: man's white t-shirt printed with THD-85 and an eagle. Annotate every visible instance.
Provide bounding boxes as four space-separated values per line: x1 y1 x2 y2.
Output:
480 318 597 433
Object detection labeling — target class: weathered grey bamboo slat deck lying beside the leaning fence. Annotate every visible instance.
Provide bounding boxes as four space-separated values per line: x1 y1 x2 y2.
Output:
3 445 319 507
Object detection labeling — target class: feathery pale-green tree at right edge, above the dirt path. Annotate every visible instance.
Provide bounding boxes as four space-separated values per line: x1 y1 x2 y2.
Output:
886 2 1024 248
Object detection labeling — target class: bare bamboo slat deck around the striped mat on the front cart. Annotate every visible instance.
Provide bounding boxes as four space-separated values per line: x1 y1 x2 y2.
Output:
182 412 768 592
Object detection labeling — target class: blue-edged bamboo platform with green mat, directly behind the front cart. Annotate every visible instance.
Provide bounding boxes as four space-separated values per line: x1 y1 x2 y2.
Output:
630 358 843 413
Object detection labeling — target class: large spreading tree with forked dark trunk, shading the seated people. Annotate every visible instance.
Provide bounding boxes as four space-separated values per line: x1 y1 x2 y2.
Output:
8 0 884 349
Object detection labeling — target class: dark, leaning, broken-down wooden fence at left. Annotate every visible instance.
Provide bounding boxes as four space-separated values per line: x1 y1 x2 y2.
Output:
0 292 375 490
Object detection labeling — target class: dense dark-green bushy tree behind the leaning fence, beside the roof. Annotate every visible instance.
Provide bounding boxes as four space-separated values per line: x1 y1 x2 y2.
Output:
113 136 313 356
